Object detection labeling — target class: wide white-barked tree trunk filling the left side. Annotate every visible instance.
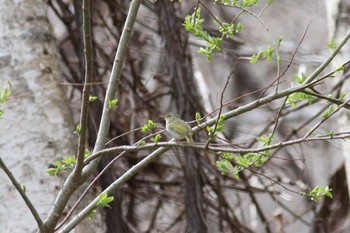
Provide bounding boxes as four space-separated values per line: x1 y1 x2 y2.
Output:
0 0 104 232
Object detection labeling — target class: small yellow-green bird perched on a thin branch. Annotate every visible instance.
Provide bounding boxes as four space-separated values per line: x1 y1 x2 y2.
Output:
161 112 194 145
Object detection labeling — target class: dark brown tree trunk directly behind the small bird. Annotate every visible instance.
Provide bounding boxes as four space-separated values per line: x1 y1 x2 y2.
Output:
157 1 207 233
